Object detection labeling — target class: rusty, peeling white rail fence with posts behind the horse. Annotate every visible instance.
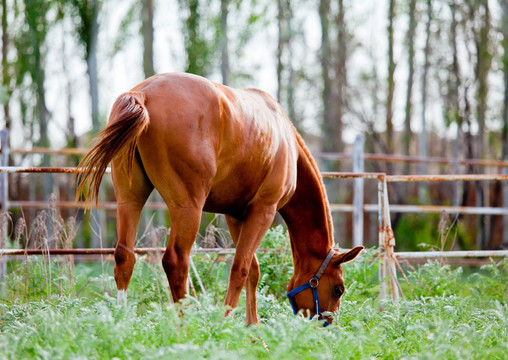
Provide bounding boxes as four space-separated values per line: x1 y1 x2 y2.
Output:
0 142 508 306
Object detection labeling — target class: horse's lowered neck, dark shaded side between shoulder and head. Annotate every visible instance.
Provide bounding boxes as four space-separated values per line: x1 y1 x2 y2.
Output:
279 142 333 266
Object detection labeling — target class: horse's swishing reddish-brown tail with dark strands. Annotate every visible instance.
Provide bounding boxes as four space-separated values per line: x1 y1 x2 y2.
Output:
75 91 150 206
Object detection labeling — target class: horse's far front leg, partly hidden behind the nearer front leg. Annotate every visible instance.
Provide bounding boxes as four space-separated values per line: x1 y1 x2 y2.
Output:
226 215 260 326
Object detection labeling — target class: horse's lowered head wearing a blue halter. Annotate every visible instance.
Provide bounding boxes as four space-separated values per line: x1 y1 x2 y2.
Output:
287 246 363 323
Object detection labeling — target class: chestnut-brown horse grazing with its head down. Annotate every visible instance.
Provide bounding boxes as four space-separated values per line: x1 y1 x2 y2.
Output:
77 74 363 324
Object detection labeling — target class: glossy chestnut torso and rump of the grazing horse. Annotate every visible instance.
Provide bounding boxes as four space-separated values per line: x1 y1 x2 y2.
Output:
133 74 297 214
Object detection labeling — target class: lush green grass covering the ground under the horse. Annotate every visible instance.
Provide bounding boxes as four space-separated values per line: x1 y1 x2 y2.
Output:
0 229 508 359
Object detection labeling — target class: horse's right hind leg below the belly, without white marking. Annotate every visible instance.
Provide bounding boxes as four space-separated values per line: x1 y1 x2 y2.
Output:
162 207 201 302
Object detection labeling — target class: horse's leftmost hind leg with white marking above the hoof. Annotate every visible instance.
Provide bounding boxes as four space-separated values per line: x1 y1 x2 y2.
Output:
111 157 153 304
